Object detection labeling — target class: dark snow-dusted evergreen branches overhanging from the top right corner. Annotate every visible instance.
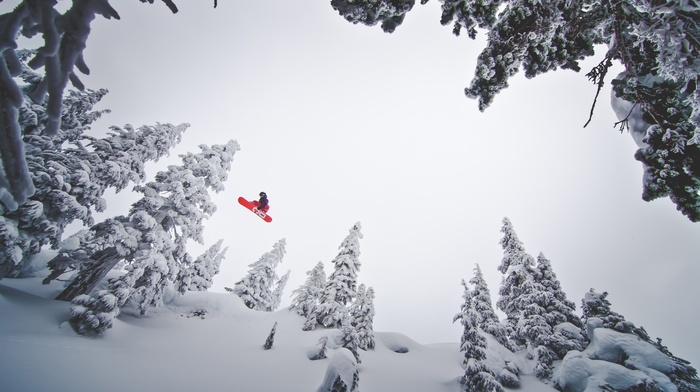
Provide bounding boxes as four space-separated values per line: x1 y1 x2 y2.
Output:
331 0 700 222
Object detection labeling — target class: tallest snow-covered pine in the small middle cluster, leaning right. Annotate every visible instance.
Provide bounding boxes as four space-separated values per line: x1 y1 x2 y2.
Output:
314 222 362 330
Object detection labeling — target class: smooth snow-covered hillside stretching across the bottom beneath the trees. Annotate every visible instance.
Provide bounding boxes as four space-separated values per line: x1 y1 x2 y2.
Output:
0 270 696 392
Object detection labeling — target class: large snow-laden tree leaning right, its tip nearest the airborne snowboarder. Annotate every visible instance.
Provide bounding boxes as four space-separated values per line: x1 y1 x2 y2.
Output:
69 140 239 334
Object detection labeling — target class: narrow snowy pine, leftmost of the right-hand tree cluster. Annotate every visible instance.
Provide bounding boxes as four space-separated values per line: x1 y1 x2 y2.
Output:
453 280 505 392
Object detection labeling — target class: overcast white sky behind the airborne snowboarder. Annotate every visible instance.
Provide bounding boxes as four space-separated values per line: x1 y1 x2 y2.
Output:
20 0 700 367
